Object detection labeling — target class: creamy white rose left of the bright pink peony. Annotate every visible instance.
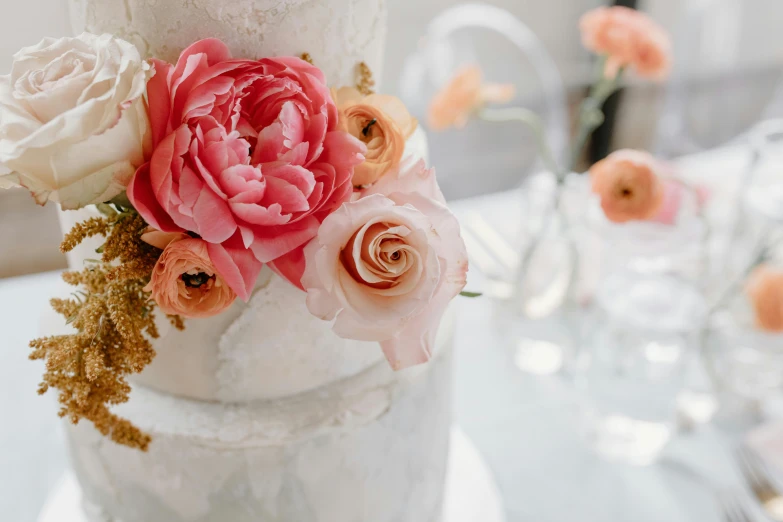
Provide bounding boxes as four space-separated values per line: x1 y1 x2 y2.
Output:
0 33 151 209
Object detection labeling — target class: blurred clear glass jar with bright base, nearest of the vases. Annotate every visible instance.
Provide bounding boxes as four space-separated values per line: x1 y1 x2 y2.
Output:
574 271 706 465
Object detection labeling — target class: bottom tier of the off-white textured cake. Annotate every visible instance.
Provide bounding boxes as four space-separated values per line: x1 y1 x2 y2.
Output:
68 338 451 522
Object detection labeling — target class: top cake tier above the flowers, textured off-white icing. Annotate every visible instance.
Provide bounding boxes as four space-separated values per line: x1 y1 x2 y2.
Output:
70 0 386 86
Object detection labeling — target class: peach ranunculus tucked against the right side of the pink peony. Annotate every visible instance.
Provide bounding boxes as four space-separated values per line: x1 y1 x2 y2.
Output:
332 87 418 187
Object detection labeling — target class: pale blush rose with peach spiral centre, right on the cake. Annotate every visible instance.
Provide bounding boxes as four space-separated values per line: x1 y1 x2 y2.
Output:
302 166 468 370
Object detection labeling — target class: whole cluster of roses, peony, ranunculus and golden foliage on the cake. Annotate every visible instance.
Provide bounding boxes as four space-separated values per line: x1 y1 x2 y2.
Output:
0 33 468 450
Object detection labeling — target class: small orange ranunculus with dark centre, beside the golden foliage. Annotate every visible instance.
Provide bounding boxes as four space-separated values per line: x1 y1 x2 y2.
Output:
144 236 237 317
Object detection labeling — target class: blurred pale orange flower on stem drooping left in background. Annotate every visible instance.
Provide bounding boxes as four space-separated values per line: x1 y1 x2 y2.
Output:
427 65 515 131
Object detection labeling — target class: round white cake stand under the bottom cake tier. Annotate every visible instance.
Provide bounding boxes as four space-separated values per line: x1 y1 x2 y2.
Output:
38 428 506 522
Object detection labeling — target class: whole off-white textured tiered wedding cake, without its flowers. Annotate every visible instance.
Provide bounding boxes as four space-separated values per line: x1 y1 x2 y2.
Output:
62 0 453 522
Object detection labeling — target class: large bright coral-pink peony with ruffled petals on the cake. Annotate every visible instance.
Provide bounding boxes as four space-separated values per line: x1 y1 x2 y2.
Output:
128 39 365 300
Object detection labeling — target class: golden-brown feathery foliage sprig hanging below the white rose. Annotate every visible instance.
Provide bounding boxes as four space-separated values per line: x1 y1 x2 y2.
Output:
30 205 183 451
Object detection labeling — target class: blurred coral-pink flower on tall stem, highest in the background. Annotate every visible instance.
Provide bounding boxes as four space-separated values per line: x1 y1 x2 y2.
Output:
579 6 671 80
